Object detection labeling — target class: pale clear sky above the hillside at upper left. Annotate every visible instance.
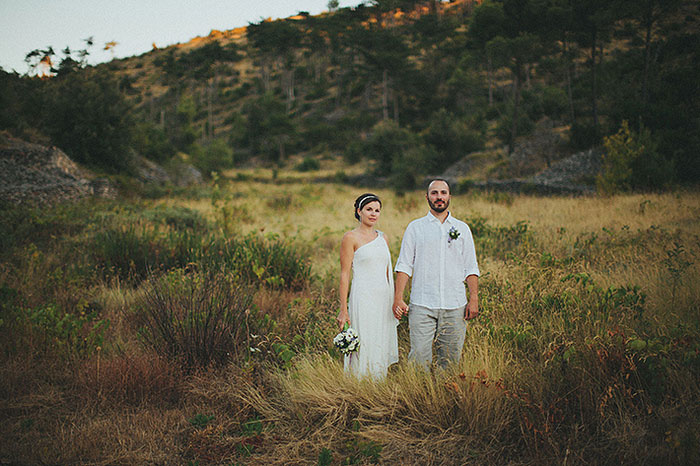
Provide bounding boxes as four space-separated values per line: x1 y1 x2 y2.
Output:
0 0 363 74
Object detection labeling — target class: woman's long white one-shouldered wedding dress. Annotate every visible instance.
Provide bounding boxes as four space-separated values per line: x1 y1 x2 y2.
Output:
345 231 399 379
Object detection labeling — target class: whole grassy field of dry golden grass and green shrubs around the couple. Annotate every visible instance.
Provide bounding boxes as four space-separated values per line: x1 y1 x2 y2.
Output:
0 170 700 465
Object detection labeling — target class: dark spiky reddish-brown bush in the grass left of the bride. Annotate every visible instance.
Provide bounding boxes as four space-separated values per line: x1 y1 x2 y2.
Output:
139 270 252 367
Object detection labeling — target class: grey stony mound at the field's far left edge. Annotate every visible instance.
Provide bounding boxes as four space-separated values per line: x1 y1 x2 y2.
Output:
0 138 117 204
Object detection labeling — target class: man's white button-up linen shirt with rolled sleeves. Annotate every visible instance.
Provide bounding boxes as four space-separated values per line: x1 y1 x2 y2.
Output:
394 212 479 309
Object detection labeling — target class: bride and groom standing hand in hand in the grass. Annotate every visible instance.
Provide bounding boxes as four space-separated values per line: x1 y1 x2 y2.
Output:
338 179 479 379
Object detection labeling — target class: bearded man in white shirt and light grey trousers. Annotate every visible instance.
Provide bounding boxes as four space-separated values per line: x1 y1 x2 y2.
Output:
393 179 479 368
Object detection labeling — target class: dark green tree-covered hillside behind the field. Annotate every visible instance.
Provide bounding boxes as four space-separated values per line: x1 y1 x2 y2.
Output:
0 0 700 189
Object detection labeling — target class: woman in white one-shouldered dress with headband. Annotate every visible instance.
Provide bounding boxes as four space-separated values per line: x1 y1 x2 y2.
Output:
338 193 399 379
